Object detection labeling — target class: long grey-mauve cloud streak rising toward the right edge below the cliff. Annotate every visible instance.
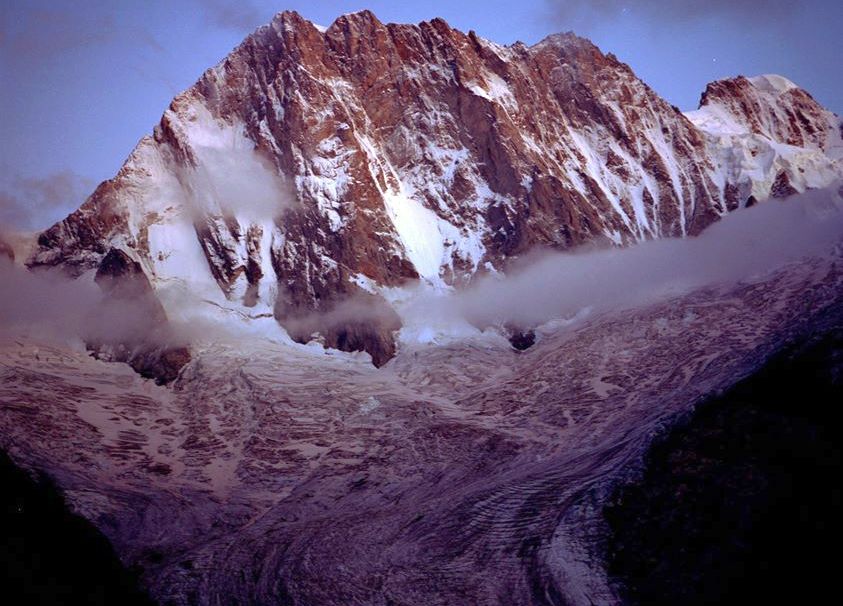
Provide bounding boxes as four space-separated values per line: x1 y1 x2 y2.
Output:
400 188 843 338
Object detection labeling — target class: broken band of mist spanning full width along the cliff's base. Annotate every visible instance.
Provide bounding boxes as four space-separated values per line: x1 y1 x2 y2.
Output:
0 184 843 356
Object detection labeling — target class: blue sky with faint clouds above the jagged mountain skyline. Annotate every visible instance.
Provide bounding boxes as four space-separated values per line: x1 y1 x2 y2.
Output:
0 0 843 229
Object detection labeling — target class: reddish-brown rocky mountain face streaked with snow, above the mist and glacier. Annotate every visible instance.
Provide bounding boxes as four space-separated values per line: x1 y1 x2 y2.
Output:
24 11 843 362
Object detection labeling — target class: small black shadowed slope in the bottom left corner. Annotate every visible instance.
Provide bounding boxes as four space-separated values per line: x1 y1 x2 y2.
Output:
0 451 153 606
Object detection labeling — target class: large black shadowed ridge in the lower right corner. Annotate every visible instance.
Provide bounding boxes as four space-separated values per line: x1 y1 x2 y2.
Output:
604 323 843 605
